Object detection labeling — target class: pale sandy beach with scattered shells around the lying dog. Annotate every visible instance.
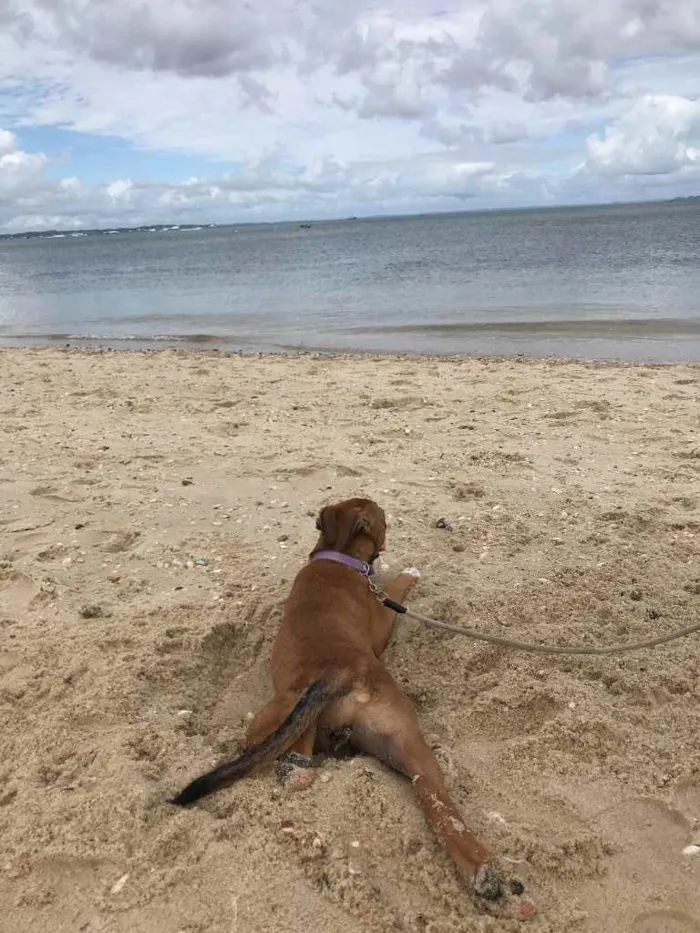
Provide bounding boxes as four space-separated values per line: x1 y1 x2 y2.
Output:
0 349 700 933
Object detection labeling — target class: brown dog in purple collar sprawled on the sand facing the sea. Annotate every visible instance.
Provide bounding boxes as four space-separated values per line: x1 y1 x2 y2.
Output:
173 499 521 901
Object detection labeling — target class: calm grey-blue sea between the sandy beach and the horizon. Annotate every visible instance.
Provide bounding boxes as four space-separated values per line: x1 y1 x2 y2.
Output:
0 200 700 362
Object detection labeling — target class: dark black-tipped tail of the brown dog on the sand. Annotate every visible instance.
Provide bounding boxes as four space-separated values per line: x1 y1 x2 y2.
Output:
170 680 349 807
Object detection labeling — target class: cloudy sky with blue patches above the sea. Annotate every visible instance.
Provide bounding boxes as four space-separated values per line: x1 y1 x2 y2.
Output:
0 0 700 233
